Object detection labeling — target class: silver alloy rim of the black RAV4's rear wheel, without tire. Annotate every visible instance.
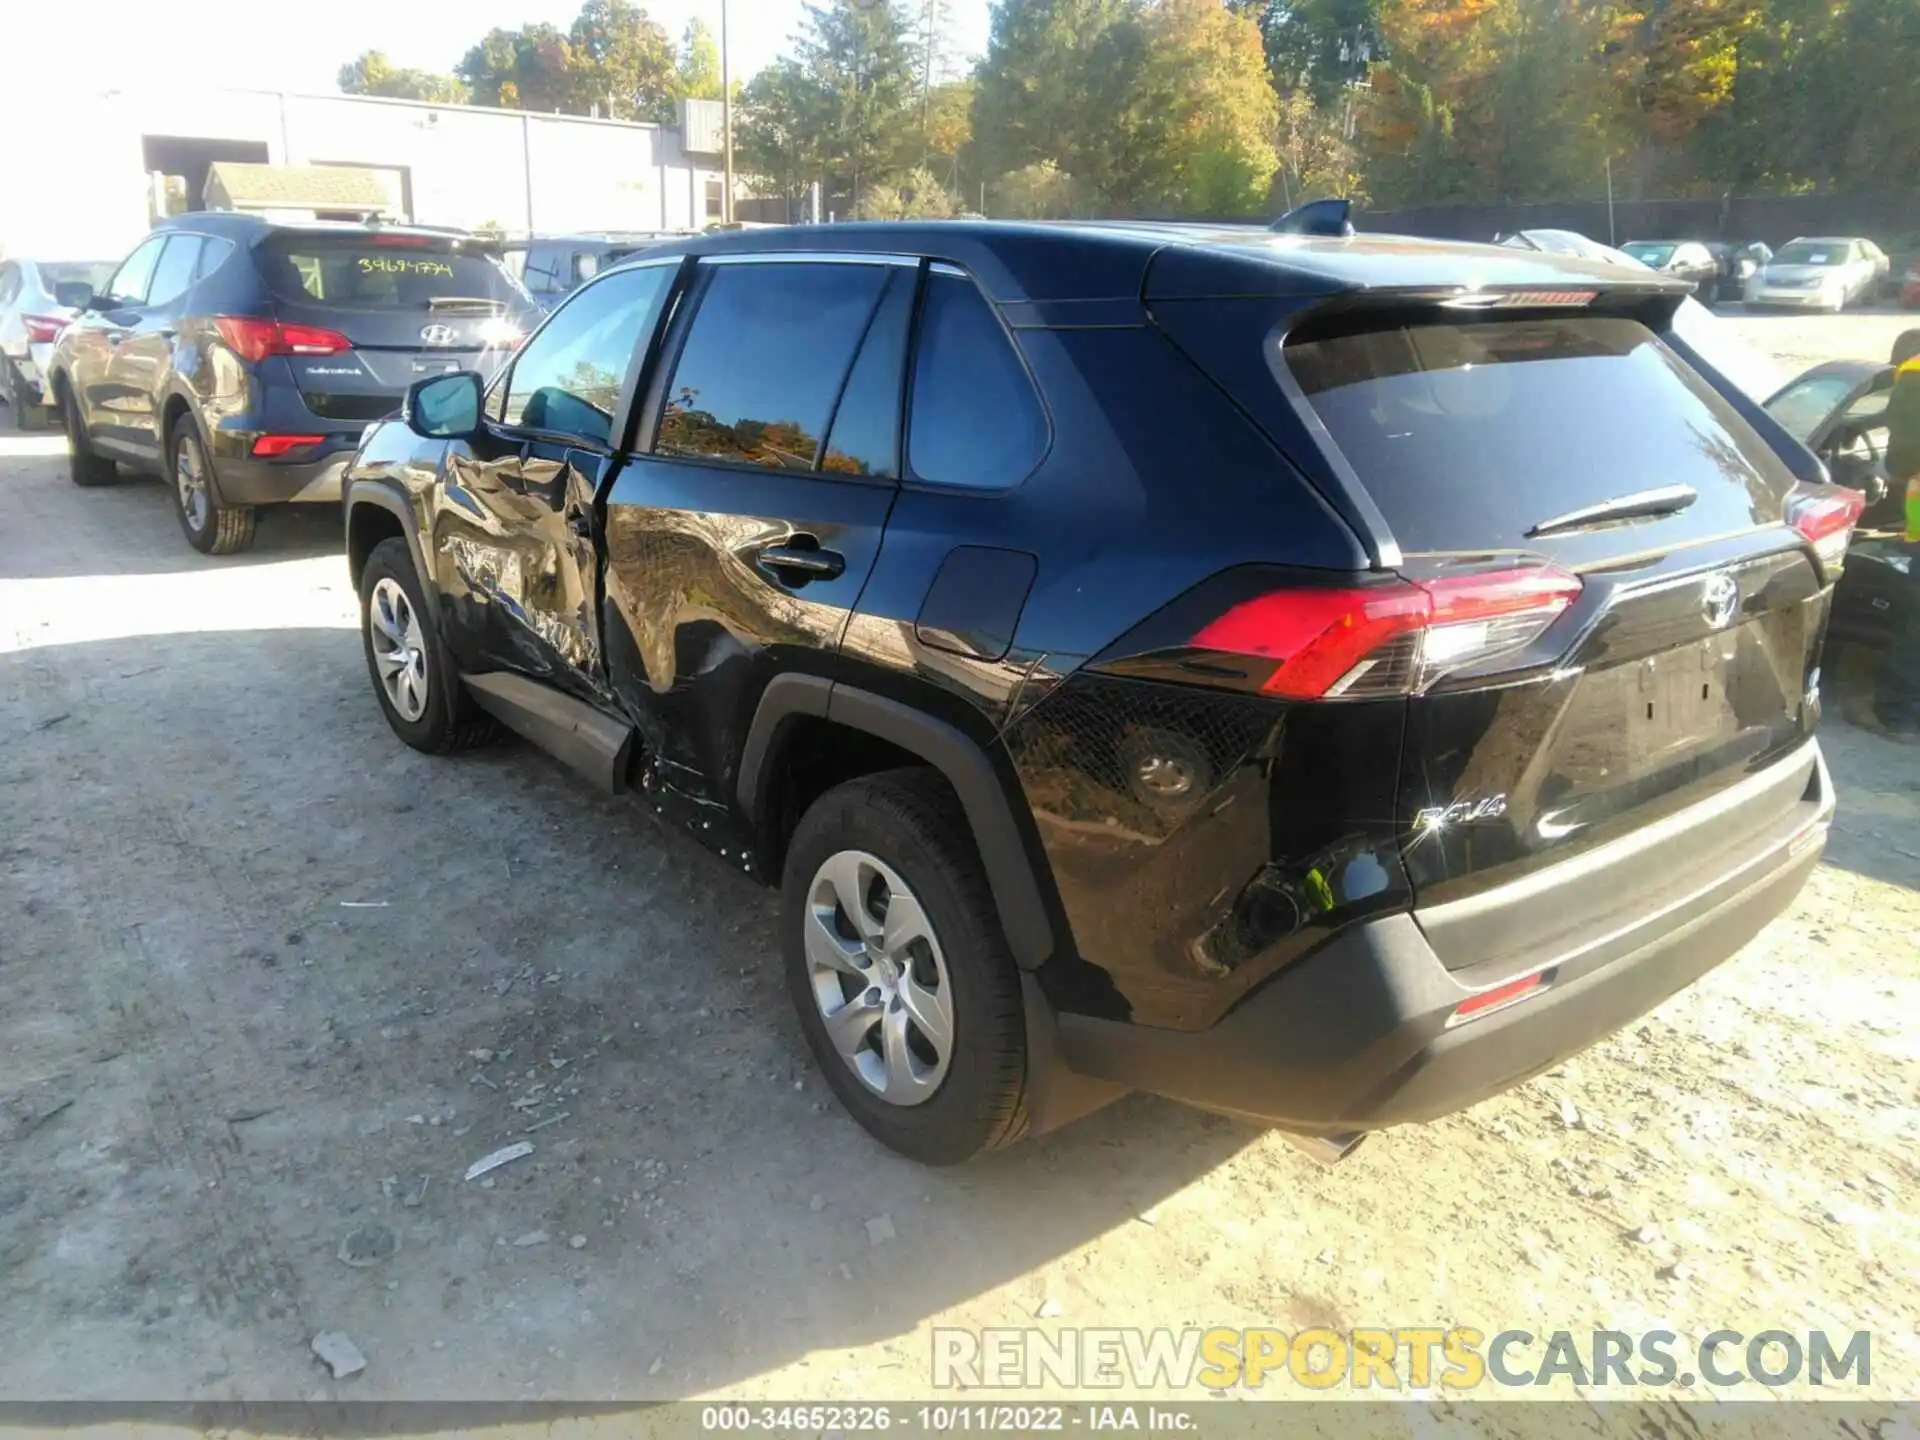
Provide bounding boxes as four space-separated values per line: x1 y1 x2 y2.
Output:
803 851 954 1106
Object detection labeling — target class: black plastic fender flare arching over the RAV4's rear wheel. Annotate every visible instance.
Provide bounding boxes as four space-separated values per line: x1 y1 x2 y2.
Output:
737 674 1054 970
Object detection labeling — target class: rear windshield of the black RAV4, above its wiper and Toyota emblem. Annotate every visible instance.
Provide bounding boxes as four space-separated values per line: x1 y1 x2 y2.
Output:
1284 315 1791 551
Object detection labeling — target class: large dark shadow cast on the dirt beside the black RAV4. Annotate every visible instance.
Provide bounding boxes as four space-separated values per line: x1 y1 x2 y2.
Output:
0 630 1259 1400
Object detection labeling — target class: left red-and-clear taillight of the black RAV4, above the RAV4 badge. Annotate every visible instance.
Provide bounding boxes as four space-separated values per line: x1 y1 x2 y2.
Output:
1190 563 1580 701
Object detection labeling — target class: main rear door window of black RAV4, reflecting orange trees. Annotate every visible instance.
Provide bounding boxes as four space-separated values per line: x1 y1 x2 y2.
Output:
655 261 891 470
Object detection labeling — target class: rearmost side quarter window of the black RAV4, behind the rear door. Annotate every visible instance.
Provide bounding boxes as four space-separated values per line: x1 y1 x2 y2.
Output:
906 271 1046 490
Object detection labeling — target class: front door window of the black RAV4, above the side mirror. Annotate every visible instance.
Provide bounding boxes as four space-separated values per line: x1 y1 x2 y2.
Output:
501 265 676 445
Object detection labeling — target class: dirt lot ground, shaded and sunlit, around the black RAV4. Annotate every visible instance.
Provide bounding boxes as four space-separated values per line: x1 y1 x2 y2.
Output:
0 307 1920 1400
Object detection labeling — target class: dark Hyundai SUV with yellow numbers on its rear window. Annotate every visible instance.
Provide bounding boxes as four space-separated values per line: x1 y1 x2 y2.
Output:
46 213 538 555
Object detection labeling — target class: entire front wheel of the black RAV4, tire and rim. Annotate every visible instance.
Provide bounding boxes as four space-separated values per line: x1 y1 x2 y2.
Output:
361 538 495 755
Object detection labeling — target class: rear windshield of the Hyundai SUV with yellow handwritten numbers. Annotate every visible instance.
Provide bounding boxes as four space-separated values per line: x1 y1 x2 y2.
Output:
253 234 520 311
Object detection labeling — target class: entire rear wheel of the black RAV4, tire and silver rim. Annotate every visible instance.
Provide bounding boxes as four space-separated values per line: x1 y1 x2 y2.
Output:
780 770 1027 1165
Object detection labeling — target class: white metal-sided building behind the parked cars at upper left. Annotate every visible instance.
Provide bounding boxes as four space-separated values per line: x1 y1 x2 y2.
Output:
0 84 722 259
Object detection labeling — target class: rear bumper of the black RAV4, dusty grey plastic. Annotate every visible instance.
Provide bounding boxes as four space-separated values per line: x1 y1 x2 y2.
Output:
1058 741 1834 1135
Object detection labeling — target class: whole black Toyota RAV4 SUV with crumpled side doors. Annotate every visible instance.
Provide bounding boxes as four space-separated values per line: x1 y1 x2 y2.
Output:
346 223 1859 1162
